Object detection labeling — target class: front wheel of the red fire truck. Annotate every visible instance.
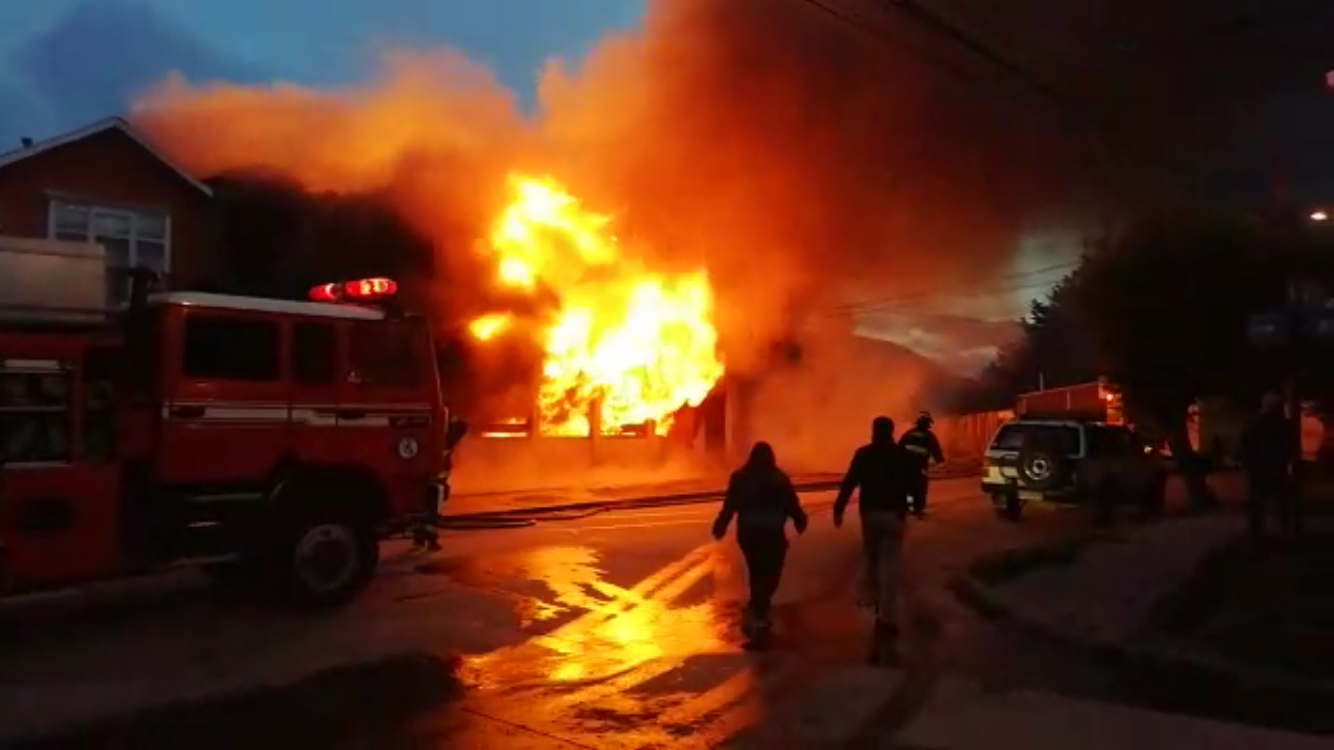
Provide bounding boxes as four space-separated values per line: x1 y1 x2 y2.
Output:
283 512 380 609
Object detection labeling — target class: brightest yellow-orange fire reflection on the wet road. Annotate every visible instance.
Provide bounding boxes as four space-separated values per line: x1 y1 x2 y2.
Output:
437 533 755 747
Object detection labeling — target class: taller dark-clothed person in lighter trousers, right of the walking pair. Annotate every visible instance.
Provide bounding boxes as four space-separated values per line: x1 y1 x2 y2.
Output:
834 416 916 665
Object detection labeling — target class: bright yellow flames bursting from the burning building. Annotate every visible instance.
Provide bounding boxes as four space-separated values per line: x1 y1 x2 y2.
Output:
472 175 723 435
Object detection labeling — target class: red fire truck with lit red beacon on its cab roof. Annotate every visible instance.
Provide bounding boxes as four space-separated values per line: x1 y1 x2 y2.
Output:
0 243 463 606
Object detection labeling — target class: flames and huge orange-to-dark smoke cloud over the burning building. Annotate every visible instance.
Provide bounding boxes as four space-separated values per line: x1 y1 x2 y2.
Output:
133 0 1099 488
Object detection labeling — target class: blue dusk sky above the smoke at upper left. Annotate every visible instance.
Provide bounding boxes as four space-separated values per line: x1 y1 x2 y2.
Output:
0 0 646 143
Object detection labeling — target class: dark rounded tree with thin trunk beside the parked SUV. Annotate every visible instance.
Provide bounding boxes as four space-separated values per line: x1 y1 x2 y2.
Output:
1073 214 1291 504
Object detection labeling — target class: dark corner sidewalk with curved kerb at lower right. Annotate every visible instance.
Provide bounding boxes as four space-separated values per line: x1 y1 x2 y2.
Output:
959 501 1334 731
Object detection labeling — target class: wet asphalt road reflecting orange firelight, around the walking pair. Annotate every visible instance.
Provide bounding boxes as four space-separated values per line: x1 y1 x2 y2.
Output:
0 479 1307 750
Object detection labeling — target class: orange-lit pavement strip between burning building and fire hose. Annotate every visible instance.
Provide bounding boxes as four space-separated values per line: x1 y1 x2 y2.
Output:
444 460 976 520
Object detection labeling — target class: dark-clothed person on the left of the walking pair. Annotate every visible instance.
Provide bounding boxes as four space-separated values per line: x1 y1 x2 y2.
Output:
714 442 807 647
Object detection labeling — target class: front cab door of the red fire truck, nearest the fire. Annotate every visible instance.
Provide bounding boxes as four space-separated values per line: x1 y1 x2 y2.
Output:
338 320 434 510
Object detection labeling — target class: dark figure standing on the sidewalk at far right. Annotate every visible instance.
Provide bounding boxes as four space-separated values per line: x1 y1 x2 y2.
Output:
1241 392 1299 542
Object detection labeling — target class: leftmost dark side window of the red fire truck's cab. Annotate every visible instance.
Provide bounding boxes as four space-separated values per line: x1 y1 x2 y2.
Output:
181 312 281 383
